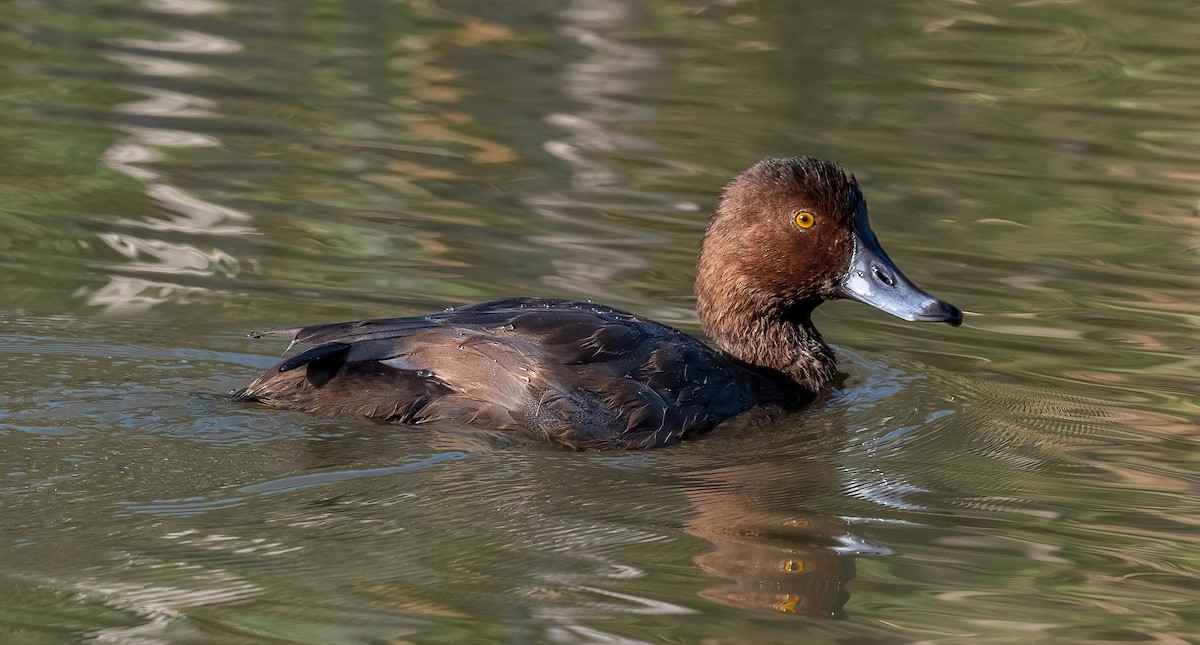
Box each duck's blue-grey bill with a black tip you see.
[838,207,962,327]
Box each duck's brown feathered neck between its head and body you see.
[696,291,838,393]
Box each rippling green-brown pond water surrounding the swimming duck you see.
[0,0,1200,644]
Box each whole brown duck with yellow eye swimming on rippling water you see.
[230,157,962,450]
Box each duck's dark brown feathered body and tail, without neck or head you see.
[233,299,762,447]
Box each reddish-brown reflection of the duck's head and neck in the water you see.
[670,424,894,617]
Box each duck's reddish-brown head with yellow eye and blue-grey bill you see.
[696,157,962,381]
